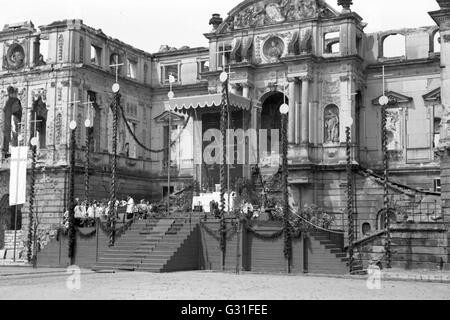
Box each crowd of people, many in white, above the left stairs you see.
[63,196,156,228]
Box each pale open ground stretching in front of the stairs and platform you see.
[0,272,450,300]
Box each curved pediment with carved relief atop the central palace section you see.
[217,0,338,33]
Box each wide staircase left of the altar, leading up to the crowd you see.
[92,218,198,272]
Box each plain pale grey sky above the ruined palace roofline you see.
[0,0,439,53]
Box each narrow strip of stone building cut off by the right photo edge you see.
[429,0,450,224]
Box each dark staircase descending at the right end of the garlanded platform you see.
[310,230,365,274]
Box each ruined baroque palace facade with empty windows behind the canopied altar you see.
[0,0,445,255]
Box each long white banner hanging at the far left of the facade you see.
[9,147,28,206]
